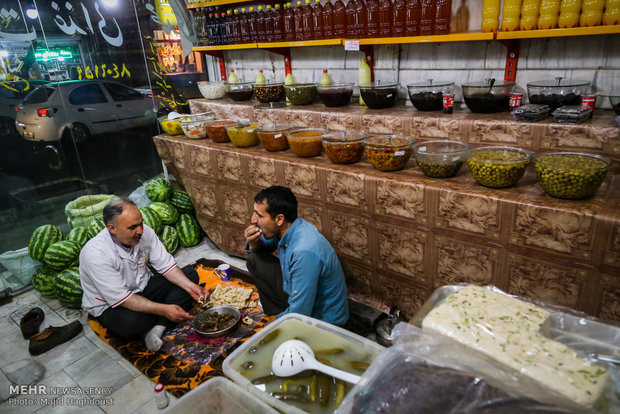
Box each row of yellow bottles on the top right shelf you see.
[482,0,620,32]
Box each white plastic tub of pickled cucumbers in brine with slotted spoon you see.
[224,313,385,414]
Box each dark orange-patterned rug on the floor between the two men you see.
[88,261,274,397]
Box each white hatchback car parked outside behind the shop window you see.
[15,79,165,143]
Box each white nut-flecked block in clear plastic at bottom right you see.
[422,286,610,406]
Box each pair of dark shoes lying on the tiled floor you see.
[19,308,82,355]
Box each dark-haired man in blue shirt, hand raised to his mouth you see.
[244,186,349,325]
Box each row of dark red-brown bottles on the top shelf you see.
[194,0,452,45]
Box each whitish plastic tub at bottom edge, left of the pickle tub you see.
[164,377,277,414]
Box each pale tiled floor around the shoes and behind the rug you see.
[0,238,246,414]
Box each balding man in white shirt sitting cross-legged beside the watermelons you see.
[80,199,208,351]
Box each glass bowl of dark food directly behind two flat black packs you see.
[527,77,591,109]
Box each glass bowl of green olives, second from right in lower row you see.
[467,146,532,188]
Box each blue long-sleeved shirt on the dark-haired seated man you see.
[252,218,349,325]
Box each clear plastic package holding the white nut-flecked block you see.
[410,285,620,413]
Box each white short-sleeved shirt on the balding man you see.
[80,225,177,316]
